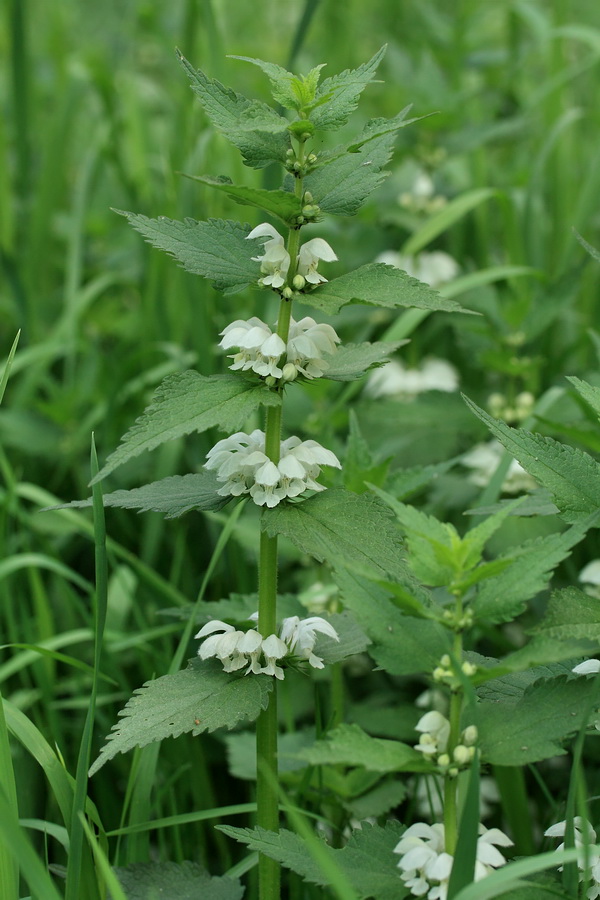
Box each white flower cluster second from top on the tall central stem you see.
[219,316,340,381]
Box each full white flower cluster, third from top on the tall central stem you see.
[204,429,341,507]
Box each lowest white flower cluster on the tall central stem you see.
[196,616,339,679]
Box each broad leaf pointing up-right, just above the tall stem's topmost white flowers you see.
[304,132,396,216]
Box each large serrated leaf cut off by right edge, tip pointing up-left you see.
[464,397,600,522]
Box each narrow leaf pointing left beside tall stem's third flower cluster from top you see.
[57,469,231,519]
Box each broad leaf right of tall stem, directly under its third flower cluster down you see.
[262,488,404,577]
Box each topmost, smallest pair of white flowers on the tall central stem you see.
[247,222,337,290]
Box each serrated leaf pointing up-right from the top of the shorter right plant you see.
[471,515,595,622]
